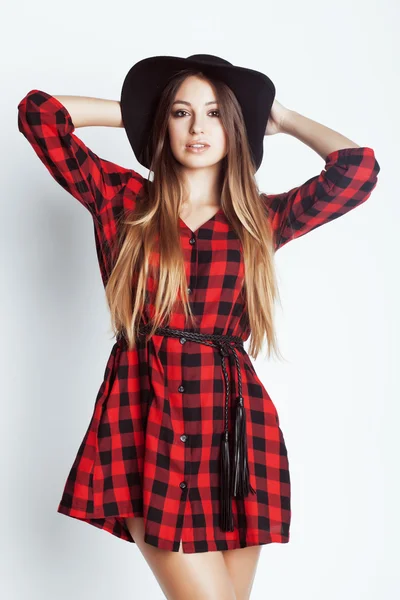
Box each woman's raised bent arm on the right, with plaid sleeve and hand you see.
[261,99,380,249]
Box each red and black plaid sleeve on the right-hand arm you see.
[261,146,380,250]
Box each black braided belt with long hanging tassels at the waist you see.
[139,324,256,531]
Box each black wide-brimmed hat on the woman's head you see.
[120,54,275,170]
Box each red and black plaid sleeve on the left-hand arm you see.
[18,89,141,217]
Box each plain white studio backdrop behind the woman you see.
[0,0,400,600]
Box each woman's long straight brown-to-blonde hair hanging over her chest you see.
[105,70,280,358]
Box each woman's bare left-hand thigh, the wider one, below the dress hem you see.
[125,517,236,600]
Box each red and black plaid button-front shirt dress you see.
[18,90,380,552]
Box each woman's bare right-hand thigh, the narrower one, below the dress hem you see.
[222,546,261,600]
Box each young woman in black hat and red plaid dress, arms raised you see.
[18,55,380,600]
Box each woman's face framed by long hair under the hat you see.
[168,76,227,169]
